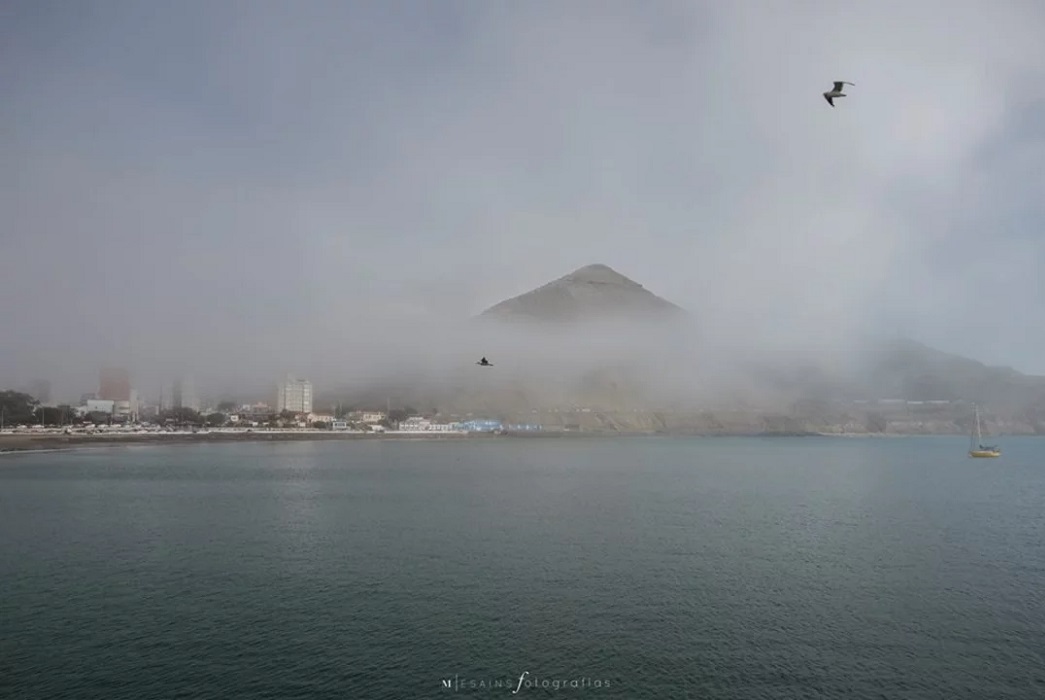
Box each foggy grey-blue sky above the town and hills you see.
[0,0,1045,403]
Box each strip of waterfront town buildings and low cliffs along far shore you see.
[0,361,1039,450]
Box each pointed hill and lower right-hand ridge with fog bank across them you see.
[332,264,1045,431]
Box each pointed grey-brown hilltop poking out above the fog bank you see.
[480,264,686,322]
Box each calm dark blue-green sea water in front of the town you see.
[0,438,1045,700]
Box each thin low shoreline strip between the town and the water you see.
[0,431,978,457]
